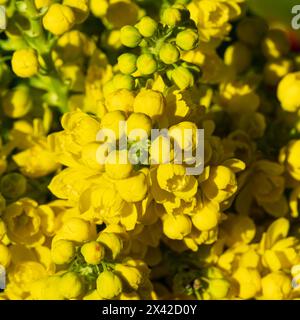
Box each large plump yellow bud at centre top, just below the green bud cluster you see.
[133,89,165,121]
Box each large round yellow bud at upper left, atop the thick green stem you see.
[43,3,76,36]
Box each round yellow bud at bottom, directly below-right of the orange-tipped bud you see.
[97,271,122,299]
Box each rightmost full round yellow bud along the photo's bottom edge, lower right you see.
[261,271,292,300]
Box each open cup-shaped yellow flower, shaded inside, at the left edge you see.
[3,199,45,246]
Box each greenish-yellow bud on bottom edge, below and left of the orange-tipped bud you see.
[59,272,84,299]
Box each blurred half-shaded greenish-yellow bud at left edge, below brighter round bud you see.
[2,85,32,119]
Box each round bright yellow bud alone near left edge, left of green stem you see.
[11,49,39,78]
